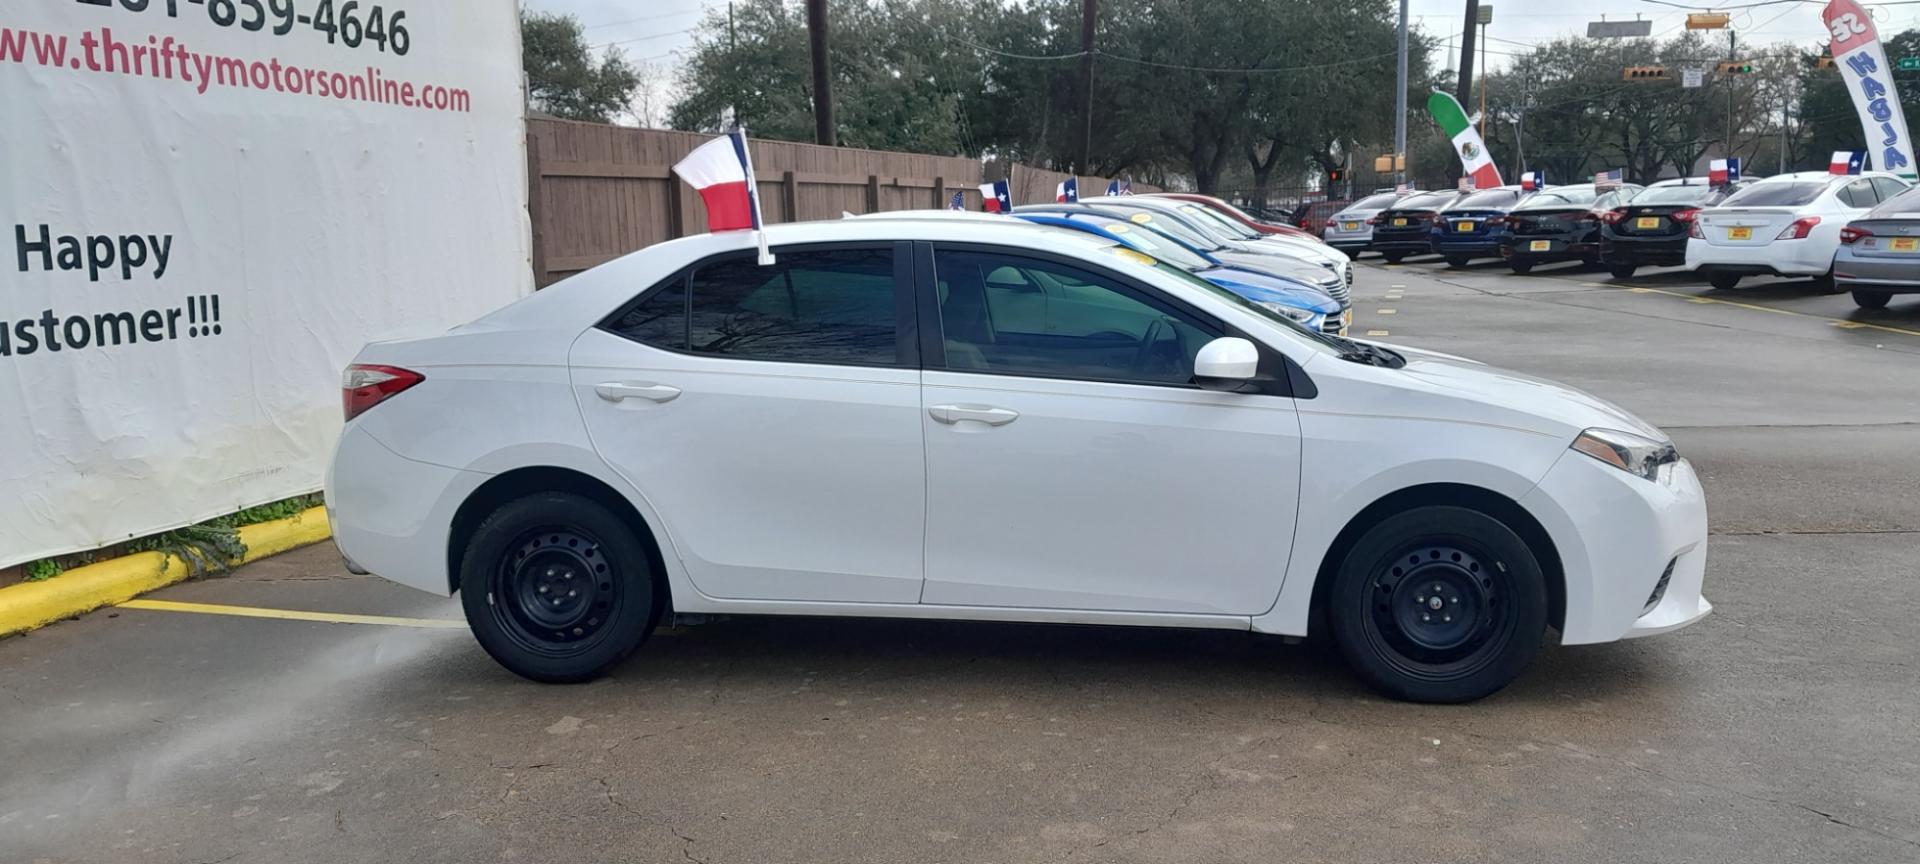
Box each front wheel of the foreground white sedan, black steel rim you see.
[1327,507,1548,703]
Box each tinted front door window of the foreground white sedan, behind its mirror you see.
[935,252,1215,386]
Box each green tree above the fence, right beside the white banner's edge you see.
[520,10,639,123]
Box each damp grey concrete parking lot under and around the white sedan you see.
[0,259,1920,864]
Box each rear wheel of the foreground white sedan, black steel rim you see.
[461,492,662,684]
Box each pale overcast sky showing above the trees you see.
[524,0,1920,121]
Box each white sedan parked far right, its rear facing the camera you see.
[1686,171,1907,292]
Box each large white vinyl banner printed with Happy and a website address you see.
[0,0,532,566]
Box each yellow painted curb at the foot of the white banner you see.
[0,507,332,636]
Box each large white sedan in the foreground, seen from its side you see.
[326,219,1713,701]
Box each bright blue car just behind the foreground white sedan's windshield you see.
[1014,209,1346,336]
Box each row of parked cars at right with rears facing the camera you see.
[1323,171,1920,309]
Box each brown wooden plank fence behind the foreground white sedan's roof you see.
[526,119,1156,288]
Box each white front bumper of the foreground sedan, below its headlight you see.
[1521,449,1713,645]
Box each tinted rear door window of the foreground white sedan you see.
[607,250,899,365]
